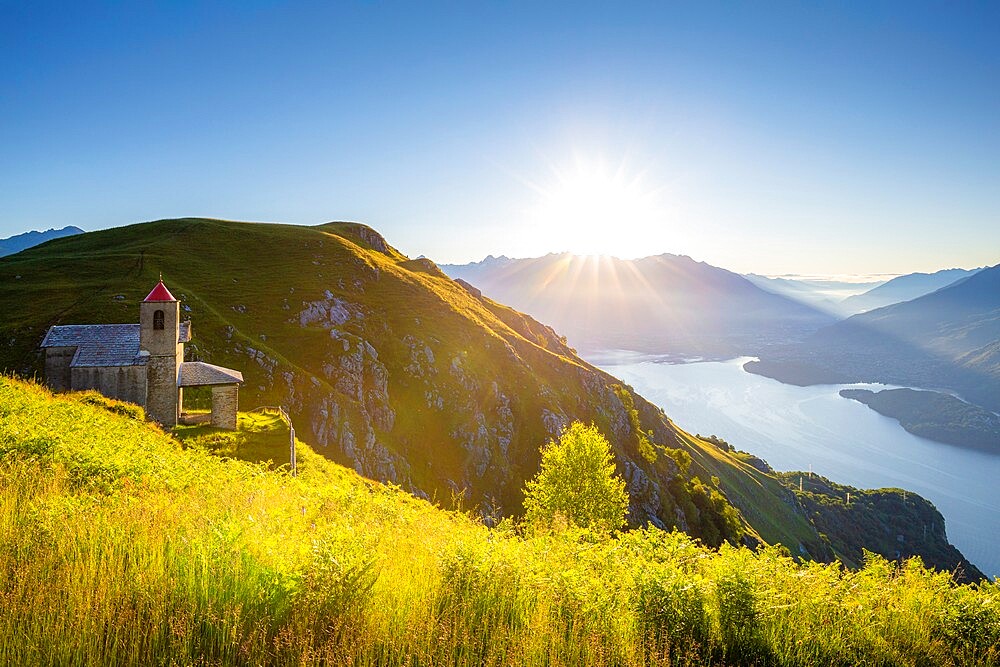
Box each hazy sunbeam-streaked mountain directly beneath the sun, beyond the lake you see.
[442,253,834,356]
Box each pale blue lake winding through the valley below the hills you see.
[587,351,1000,577]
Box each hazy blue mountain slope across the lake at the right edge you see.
[747,265,1000,412]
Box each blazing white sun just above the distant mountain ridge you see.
[529,156,666,257]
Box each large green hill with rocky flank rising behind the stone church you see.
[0,219,823,556]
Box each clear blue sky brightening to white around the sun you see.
[0,0,1000,274]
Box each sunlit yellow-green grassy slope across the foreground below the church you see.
[0,379,1000,665]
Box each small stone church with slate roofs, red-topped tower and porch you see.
[41,278,243,429]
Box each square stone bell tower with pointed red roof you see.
[139,276,184,427]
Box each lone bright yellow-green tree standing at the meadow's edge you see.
[524,422,628,530]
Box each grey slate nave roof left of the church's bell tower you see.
[41,324,146,366]
